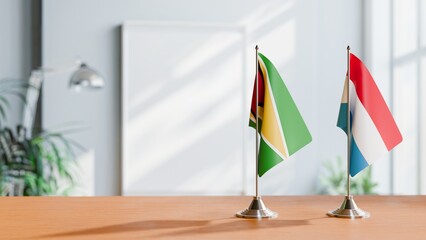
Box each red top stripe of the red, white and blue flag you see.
[350,53,402,151]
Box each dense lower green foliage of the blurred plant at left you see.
[0,122,78,195]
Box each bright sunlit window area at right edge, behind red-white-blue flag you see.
[365,0,426,195]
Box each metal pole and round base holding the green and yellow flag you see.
[235,45,278,219]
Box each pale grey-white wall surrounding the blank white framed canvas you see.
[43,0,363,195]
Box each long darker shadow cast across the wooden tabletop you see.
[39,218,316,238]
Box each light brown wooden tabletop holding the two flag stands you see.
[0,196,426,240]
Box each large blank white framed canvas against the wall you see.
[122,22,246,195]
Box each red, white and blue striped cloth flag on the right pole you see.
[337,53,402,177]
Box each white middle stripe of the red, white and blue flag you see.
[350,81,388,164]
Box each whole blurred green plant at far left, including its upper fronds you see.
[0,80,81,196]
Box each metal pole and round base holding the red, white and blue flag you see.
[327,46,370,219]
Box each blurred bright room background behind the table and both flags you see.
[0,0,426,196]
